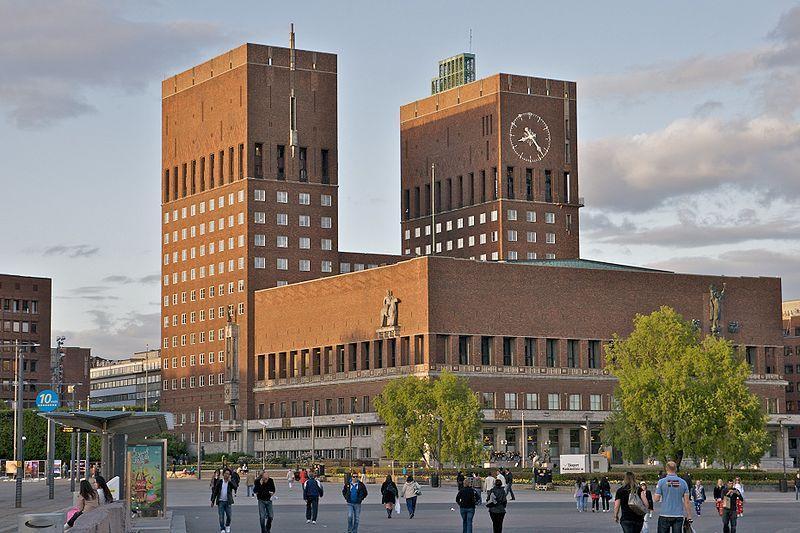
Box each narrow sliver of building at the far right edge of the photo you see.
[783,300,800,466]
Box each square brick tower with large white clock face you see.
[400,70,583,261]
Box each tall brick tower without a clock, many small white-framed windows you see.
[161,34,397,451]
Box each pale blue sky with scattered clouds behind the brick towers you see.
[0,0,800,357]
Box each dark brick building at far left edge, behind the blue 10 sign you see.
[0,274,52,407]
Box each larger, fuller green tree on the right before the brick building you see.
[604,307,769,466]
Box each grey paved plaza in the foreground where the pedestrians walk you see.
[169,480,800,533]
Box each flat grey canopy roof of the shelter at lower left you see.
[39,411,175,438]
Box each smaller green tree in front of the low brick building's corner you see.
[375,372,483,465]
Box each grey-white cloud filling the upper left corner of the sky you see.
[0,0,228,128]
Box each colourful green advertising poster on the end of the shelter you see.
[125,440,166,516]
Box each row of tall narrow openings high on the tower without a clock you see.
[163,143,330,202]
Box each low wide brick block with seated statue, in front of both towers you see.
[247,257,786,465]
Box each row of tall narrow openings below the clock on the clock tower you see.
[402,165,574,220]
